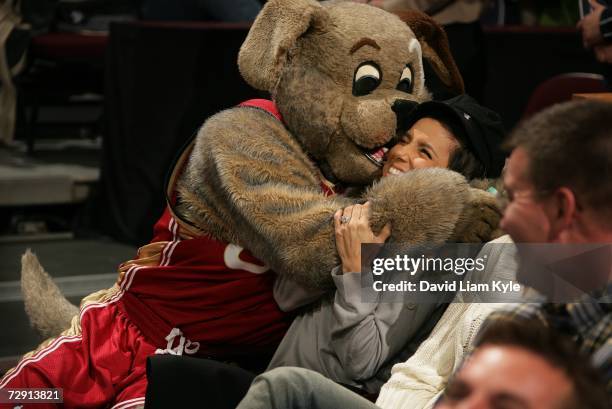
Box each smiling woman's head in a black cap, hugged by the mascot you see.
[383,95,505,179]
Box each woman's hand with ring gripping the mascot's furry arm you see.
[334,202,391,273]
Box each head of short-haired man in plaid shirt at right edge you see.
[501,101,612,243]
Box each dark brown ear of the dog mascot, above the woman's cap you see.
[393,10,465,94]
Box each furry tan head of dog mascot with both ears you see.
[238,0,463,184]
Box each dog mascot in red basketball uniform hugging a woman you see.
[0,0,499,409]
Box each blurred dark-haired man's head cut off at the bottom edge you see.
[436,320,608,409]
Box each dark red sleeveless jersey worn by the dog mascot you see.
[119,100,290,359]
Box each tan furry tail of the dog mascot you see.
[21,249,79,337]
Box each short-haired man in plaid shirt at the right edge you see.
[478,101,612,396]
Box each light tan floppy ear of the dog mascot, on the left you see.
[238,0,328,91]
